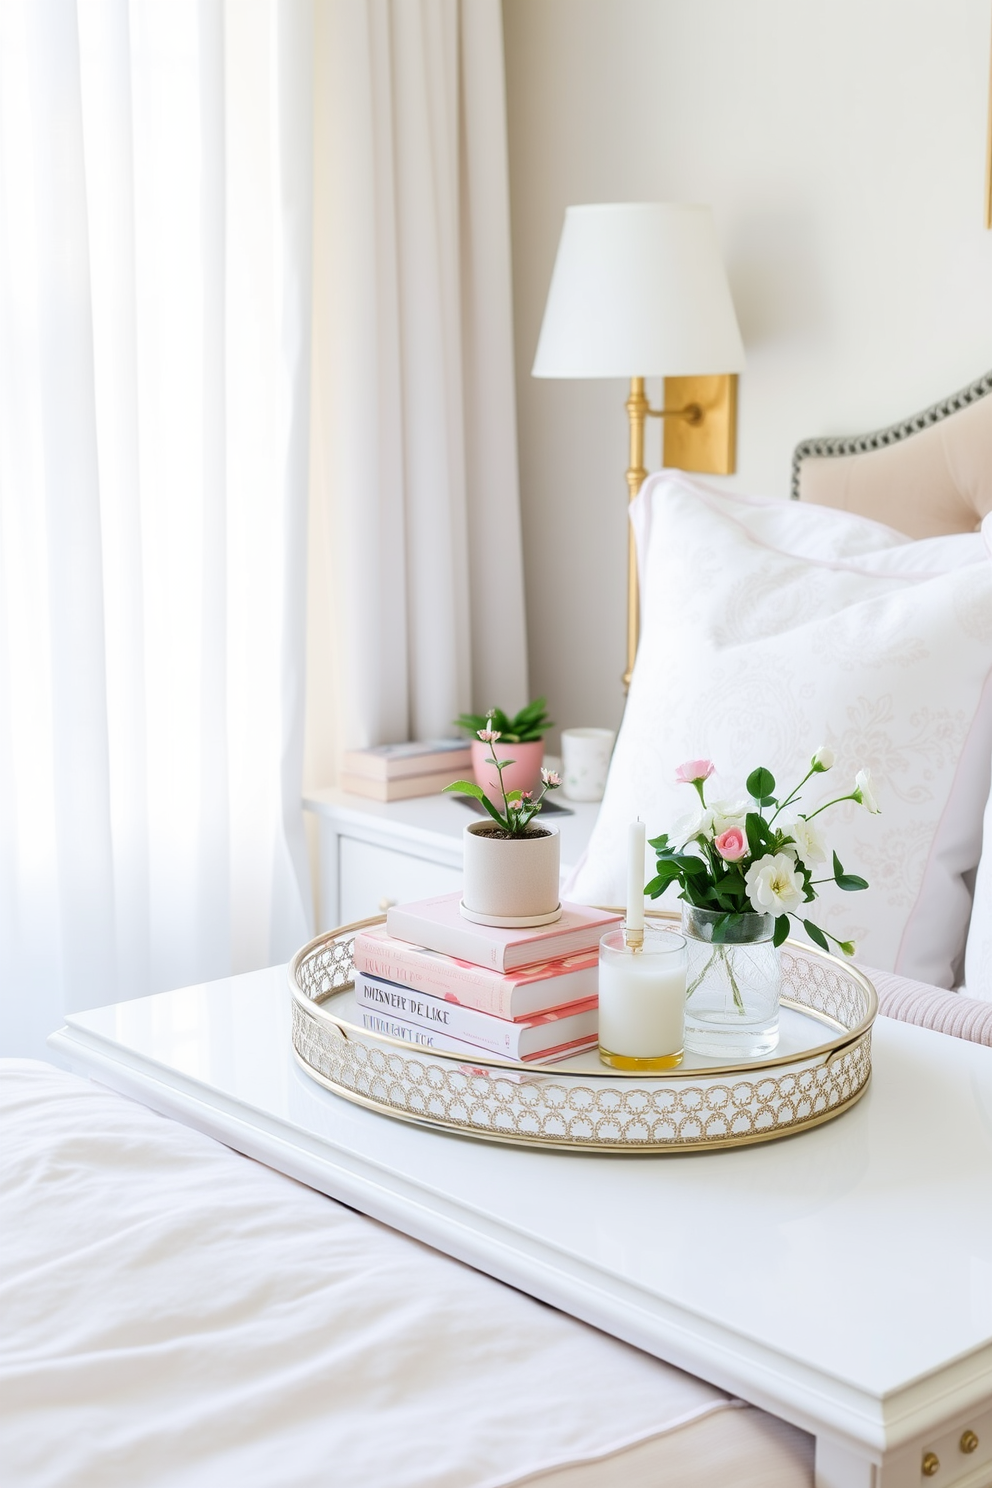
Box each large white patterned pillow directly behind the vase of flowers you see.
[565,472,992,987]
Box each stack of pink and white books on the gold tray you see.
[354,893,620,1064]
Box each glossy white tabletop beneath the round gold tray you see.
[55,969,992,1448]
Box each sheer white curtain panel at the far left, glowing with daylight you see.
[0,0,312,1055]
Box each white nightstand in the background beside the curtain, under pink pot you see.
[303,789,599,933]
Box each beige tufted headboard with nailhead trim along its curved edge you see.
[793,372,992,537]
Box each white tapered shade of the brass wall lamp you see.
[534,202,744,378]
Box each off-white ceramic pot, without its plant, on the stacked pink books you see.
[461,817,562,927]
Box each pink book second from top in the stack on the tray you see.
[352,926,599,1021]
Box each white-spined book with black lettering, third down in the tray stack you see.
[355,972,599,1059]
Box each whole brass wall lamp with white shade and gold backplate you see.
[532,202,744,690]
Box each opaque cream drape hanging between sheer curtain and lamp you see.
[308,0,526,784]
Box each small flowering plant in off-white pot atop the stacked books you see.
[445,714,562,926]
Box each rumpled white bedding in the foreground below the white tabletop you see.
[0,1061,812,1488]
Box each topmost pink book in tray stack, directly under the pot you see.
[385,890,622,972]
